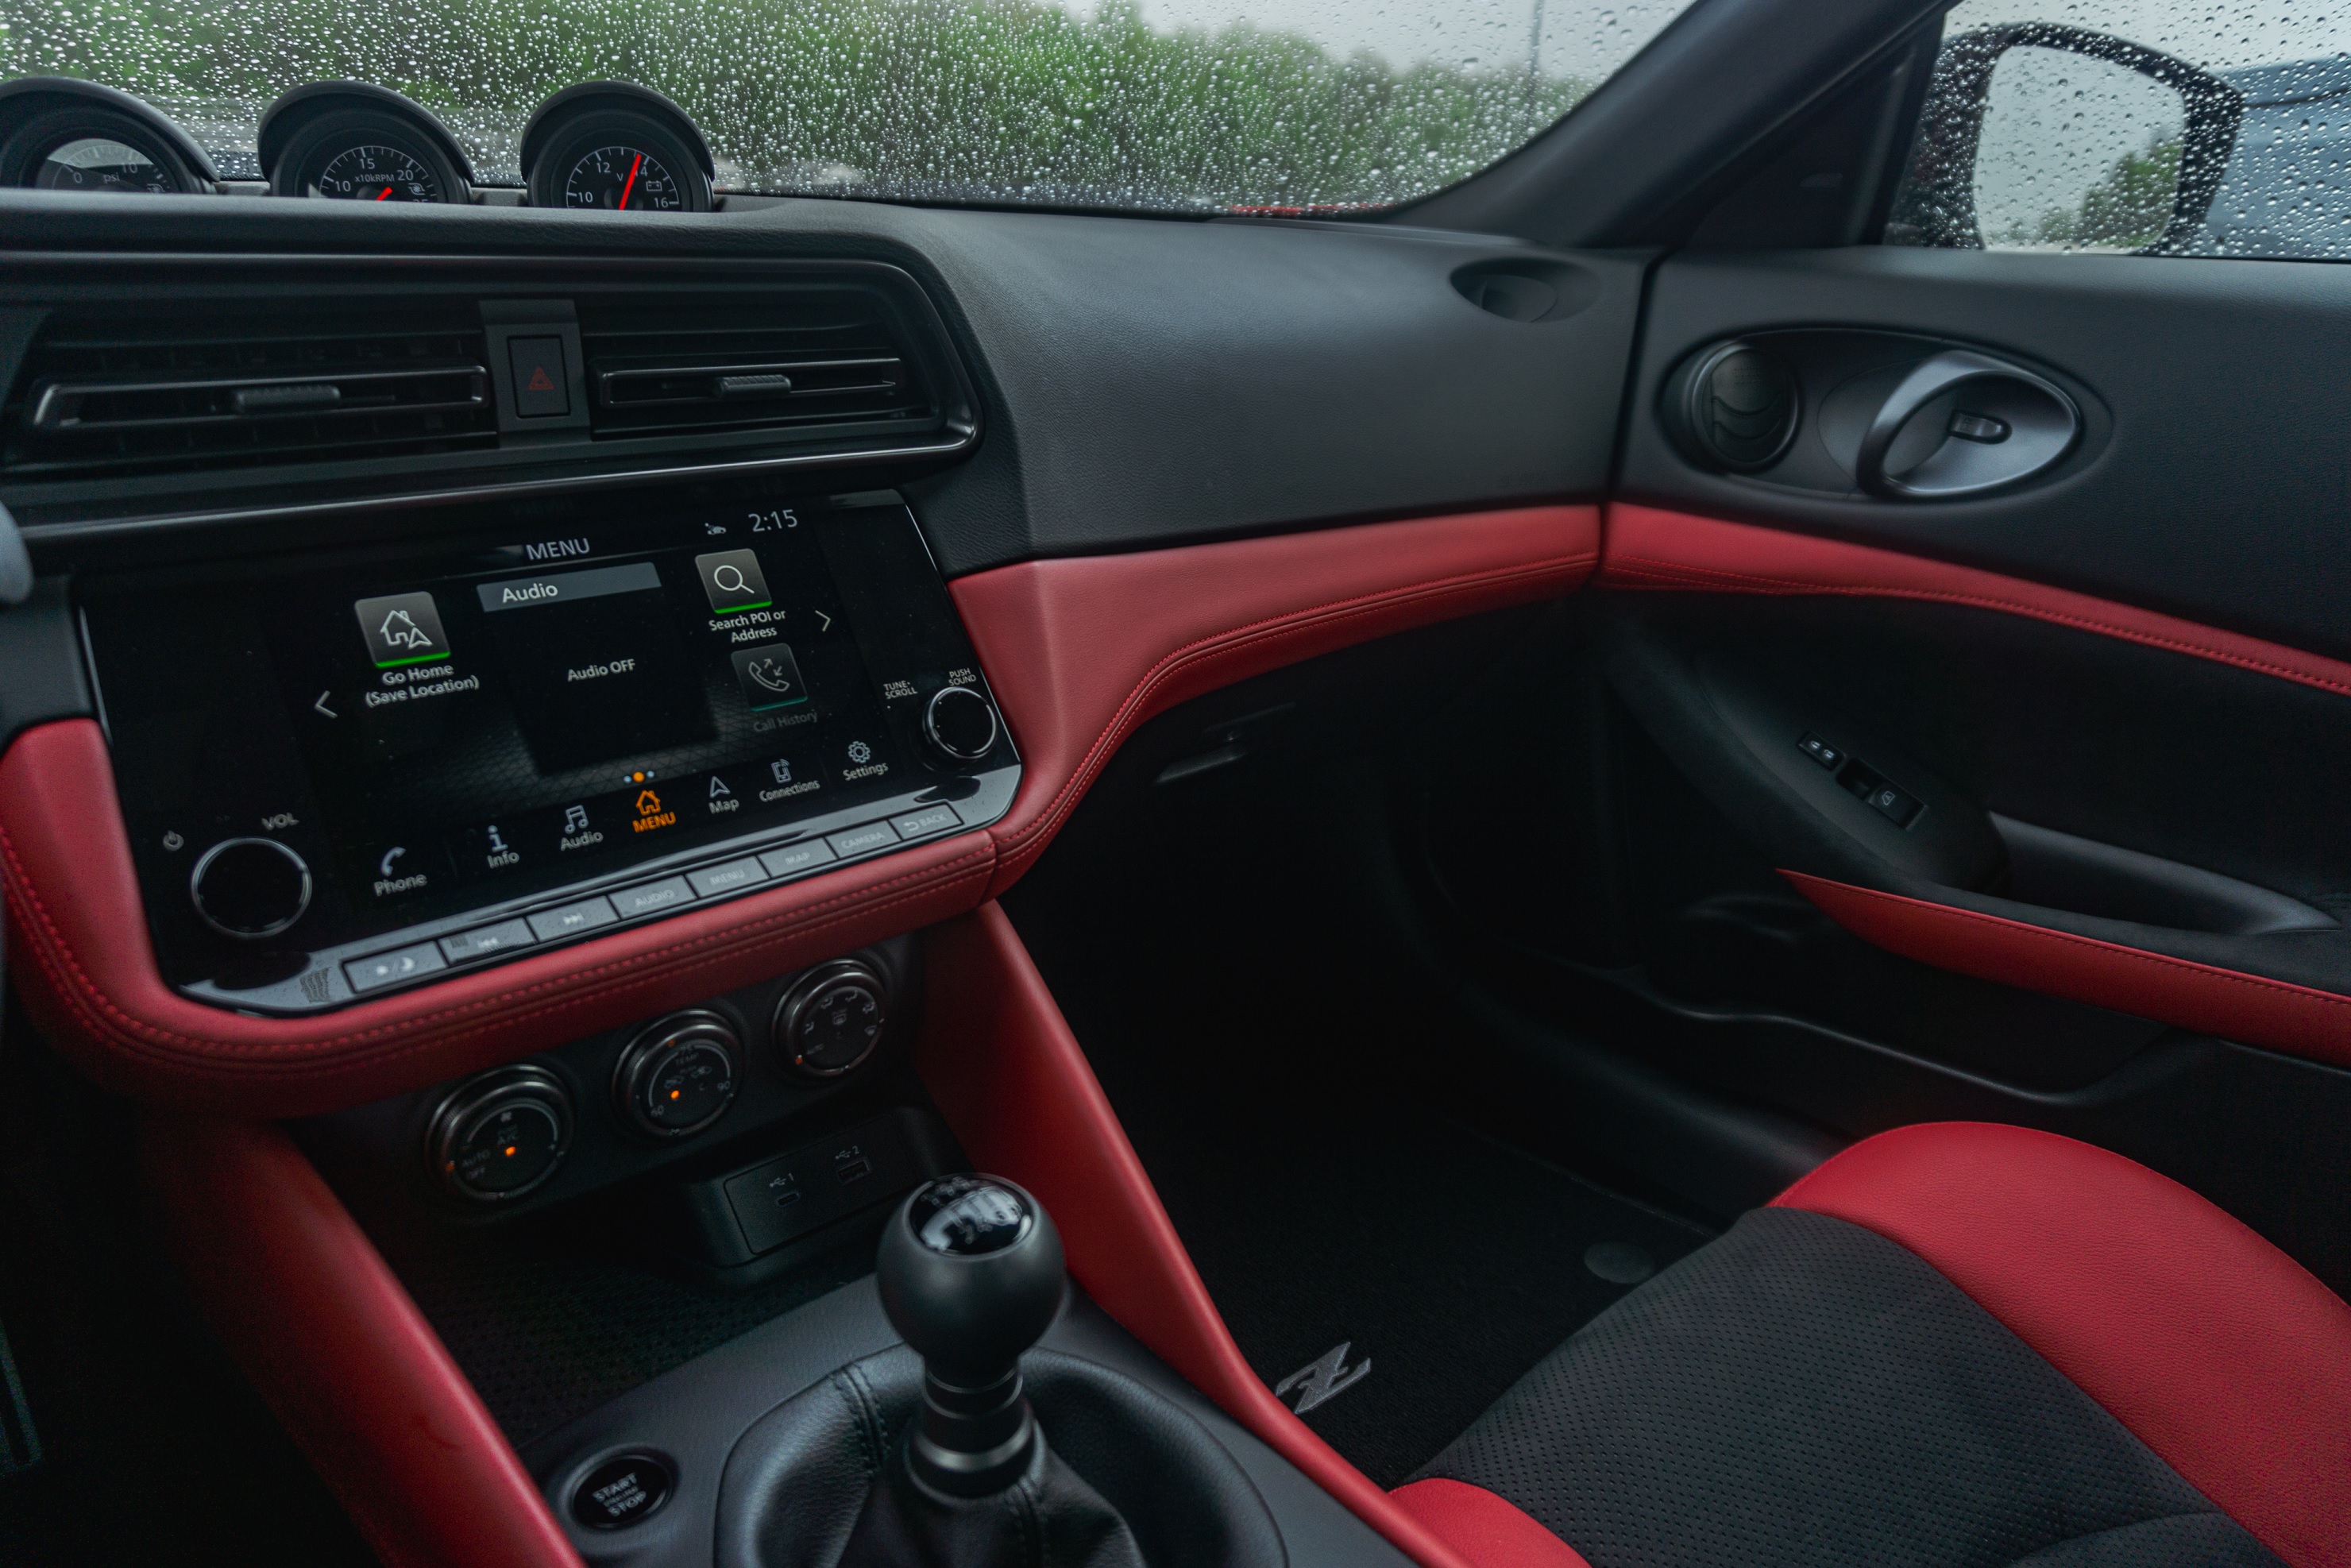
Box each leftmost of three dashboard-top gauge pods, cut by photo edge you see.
[0,75,221,195]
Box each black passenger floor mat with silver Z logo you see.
[1112,1067,1707,1485]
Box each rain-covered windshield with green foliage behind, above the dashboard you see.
[0,0,1688,211]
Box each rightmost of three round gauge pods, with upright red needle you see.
[522,83,717,211]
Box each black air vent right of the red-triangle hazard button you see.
[581,294,936,437]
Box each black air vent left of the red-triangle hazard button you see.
[5,306,496,480]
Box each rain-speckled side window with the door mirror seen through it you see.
[1886,0,2351,259]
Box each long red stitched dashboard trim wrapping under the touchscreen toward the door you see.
[0,505,1599,1117]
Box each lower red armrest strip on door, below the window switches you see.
[1780,870,2351,1068]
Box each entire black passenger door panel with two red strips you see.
[1392,236,2351,1284]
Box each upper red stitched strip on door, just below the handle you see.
[1599,503,2351,696]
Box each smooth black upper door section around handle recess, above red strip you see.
[1617,247,2351,658]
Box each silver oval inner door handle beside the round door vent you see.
[1855,348,2081,500]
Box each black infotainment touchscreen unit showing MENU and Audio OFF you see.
[85,486,1016,1006]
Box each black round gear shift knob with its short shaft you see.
[874,1176,1063,1497]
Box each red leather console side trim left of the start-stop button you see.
[141,1117,581,1568]
